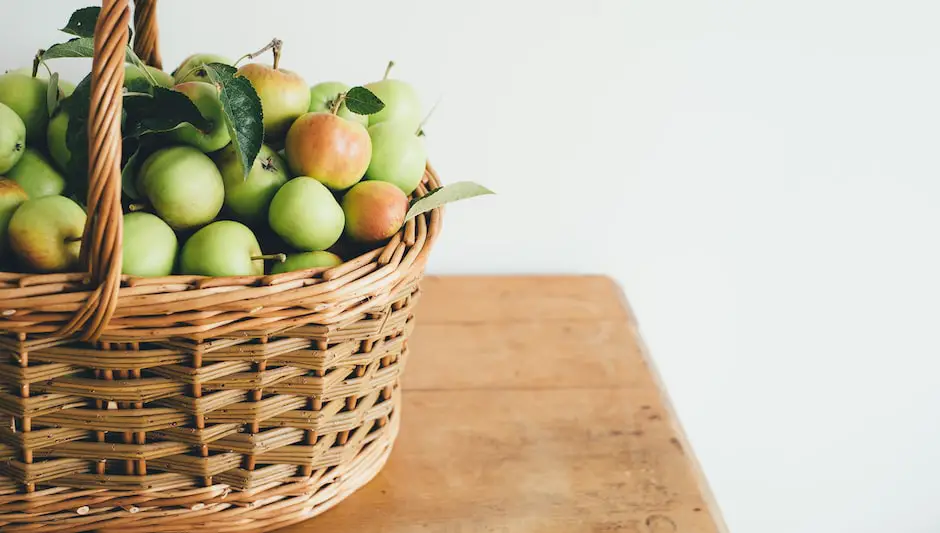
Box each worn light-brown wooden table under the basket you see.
[283,276,726,533]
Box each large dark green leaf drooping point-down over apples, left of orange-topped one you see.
[204,63,264,179]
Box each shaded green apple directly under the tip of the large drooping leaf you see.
[214,145,290,223]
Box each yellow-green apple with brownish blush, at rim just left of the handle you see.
[7,196,85,272]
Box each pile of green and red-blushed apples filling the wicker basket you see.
[0,46,427,277]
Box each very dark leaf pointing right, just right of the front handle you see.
[124,87,211,137]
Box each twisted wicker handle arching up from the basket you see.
[59,0,160,341]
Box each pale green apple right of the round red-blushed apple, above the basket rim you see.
[366,122,428,194]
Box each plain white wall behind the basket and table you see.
[0,0,940,533]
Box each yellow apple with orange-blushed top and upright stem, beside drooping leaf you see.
[236,63,310,143]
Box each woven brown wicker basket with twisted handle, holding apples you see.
[0,0,441,533]
